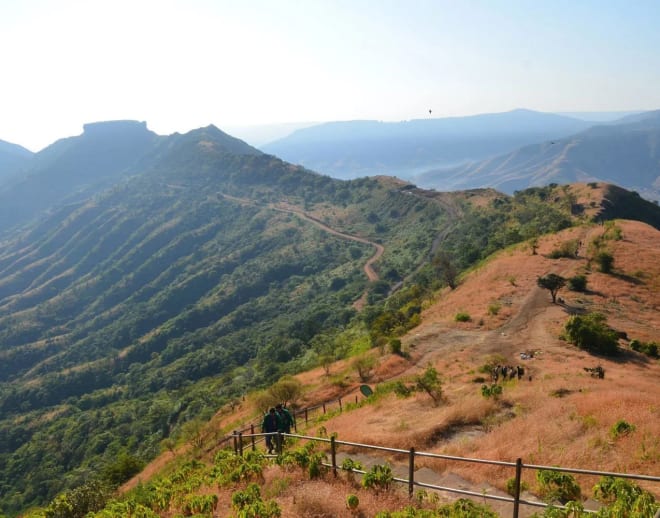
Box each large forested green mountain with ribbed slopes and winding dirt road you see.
[0,123,660,515]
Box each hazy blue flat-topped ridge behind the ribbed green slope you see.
[0,120,261,233]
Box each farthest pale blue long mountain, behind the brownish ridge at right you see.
[262,110,592,178]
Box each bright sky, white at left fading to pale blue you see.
[0,0,660,151]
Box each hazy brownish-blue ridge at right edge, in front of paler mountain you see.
[415,110,660,200]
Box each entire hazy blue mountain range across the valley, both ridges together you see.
[263,110,660,200]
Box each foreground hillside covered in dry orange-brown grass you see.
[24,217,660,517]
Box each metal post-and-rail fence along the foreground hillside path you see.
[217,396,660,518]
